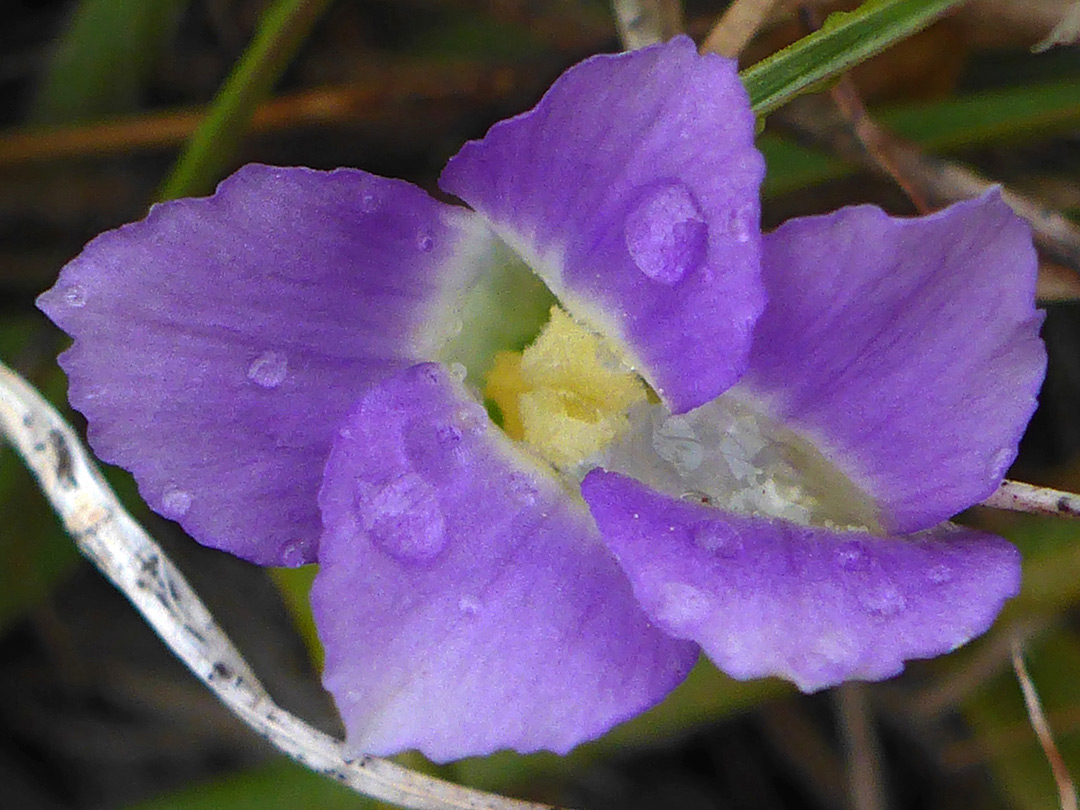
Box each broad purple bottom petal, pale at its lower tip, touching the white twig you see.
[312,365,697,760]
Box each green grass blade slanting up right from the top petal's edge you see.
[741,0,963,116]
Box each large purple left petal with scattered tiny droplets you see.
[38,165,494,565]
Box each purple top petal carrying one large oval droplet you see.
[440,37,765,411]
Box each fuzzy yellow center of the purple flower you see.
[484,307,648,472]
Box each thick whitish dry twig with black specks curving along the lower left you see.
[0,363,548,810]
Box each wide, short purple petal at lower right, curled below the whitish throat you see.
[582,470,1020,691]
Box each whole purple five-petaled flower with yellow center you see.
[40,38,1044,760]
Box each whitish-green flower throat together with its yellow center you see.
[438,244,881,531]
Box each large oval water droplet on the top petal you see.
[623,181,708,284]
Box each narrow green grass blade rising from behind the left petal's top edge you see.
[158,0,330,200]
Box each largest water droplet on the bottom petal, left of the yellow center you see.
[357,473,447,563]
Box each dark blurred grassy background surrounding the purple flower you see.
[0,0,1080,810]
